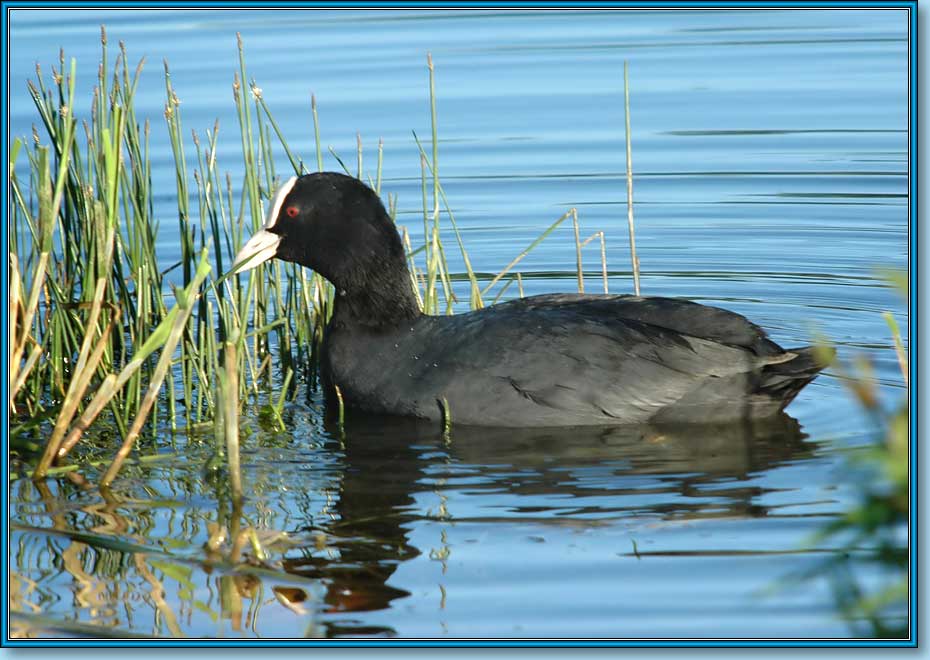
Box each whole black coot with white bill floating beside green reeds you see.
[234,173,825,427]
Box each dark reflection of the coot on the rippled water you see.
[285,414,815,636]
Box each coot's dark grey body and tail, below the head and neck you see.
[324,295,819,427]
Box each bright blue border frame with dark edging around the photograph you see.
[0,0,919,648]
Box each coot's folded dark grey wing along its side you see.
[411,297,777,426]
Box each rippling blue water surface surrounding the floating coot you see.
[10,10,908,638]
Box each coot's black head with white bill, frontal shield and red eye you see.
[233,172,418,322]
